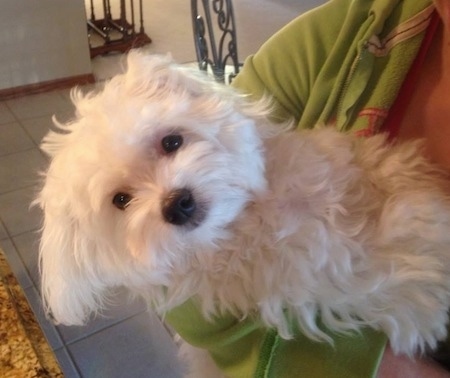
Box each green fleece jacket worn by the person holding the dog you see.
[165,0,434,378]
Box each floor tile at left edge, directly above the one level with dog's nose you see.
[0,148,48,193]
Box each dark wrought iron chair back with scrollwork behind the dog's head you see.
[191,0,241,83]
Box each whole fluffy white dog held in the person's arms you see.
[37,52,450,374]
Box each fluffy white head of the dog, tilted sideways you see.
[37,52,265,324]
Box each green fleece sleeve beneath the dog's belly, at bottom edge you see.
[164,298,386,378]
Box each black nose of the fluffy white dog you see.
[162,189,196,226]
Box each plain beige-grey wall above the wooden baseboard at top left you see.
[0,0,92,90]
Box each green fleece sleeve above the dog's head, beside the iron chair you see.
[233,0,353,125]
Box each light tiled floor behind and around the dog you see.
[0,0,323,378]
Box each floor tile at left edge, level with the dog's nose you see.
[0,187,42,236]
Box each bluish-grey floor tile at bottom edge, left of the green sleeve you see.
[68,312,182,378]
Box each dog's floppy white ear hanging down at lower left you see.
[39,204,103,325]
